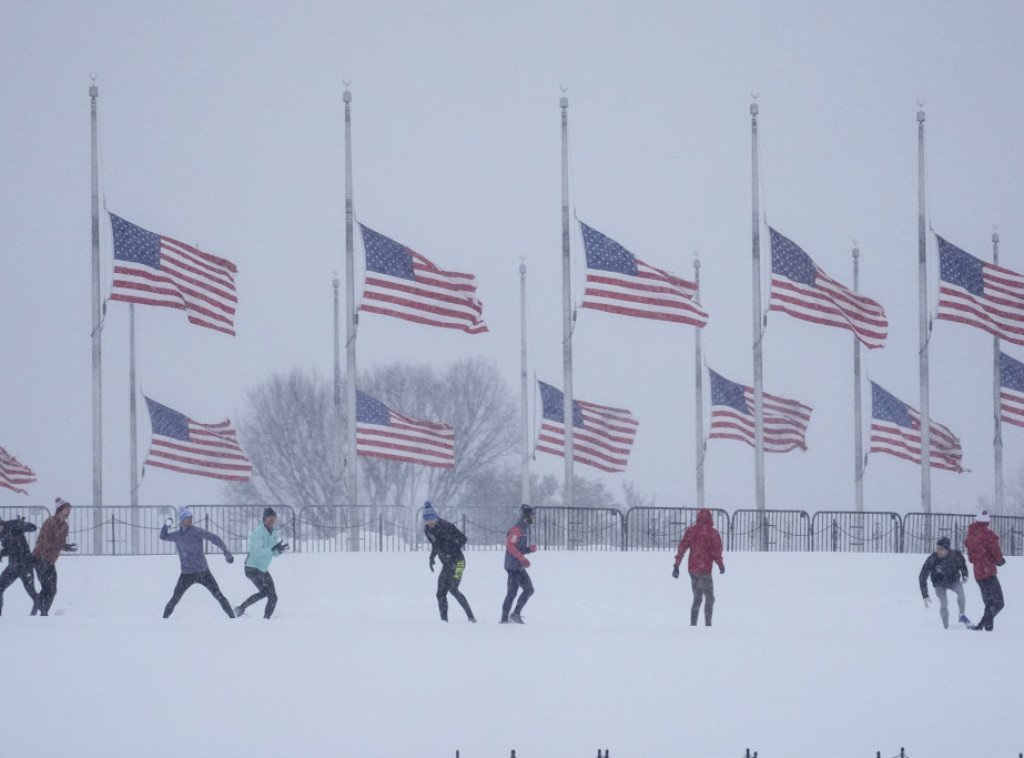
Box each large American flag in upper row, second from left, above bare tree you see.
[359,223,487,334]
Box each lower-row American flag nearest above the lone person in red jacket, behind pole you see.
[708,369,811,453]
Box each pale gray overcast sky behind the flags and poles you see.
[0,0,1024,512]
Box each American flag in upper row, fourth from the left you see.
[768,227,889,347]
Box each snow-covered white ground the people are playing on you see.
[0,552,1024,758]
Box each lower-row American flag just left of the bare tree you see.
[143,397,253,481]
